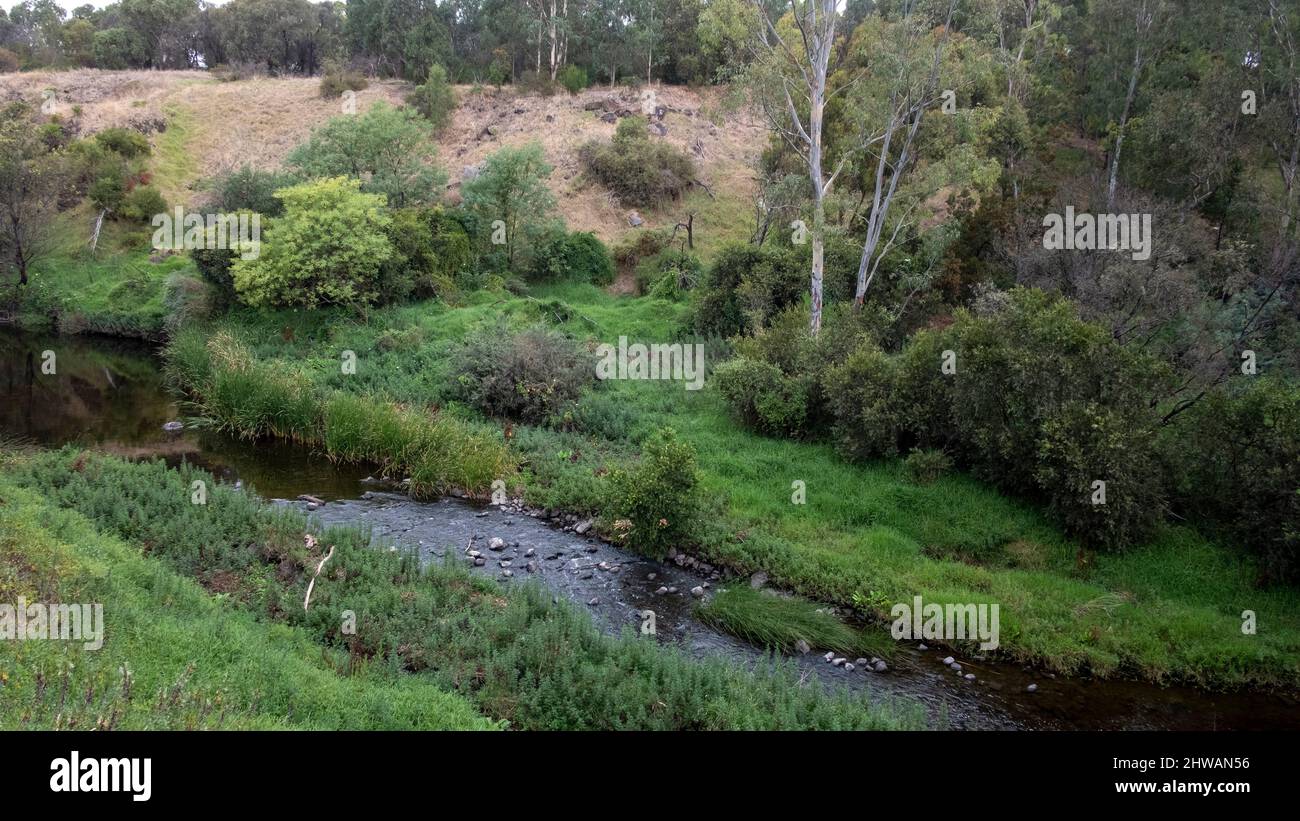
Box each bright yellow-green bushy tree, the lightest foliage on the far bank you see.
[231,177,393,308]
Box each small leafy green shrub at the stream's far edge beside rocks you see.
[605,427,699,559]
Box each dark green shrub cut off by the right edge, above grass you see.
[1161,378,1300,582]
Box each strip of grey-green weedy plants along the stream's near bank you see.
[9,449,923,729]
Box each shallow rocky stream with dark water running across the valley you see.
[0,330,1300,730]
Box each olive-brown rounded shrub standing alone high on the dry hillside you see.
[579,117,696,205]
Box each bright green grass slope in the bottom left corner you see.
[0,481,494,730]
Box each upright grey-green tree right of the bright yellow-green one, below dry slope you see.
[460,143,555,270]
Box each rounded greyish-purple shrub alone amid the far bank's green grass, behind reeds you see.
[452,327,595,423]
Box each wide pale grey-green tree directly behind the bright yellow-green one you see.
[289,101,447,208]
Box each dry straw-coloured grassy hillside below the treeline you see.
[0,69,766,256]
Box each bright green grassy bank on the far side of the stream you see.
[162,286,1300,687]
